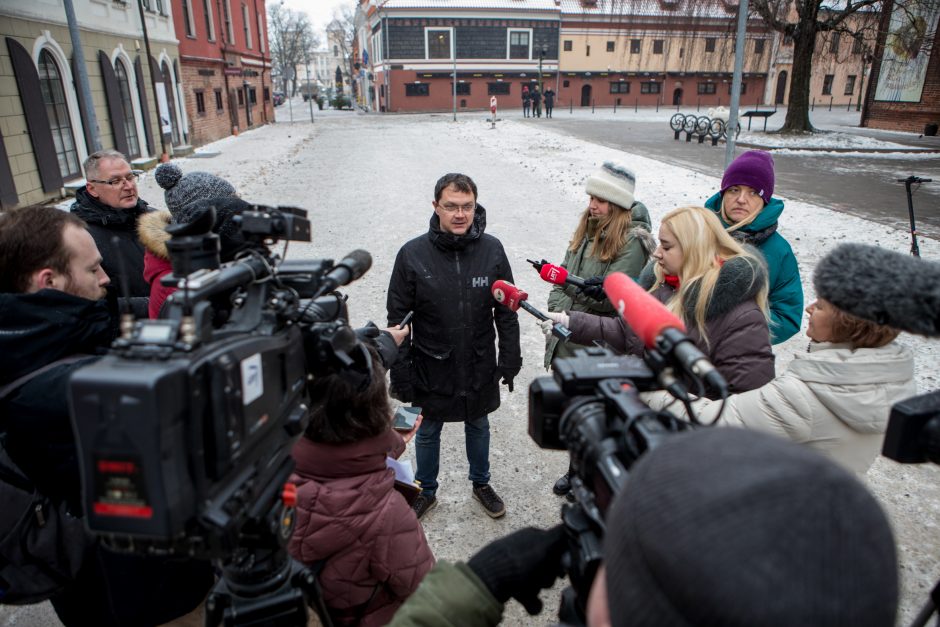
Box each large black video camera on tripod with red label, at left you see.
[70,205,371,625]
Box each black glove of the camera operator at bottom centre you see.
[467,525,567,616]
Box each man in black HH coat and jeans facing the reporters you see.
[388,174,522,518]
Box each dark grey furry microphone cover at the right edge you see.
[813,244,940,337]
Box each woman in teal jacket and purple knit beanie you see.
[705,150,803,344]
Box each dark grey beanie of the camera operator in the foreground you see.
[604,427,898,627]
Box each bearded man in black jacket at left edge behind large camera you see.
[0,207,213,626]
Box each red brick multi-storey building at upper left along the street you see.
[172,0,274,146]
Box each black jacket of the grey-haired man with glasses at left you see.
[72,188,152,297]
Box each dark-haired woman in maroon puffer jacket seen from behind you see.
[288,349,434,627]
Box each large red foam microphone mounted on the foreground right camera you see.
[604,272,728,396]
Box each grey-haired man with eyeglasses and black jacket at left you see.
[72,150,151,297]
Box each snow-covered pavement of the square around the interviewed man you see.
[9,108,940,626]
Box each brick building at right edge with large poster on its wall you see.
[861,2,940,133]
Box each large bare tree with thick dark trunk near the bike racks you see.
[750,0,884,133]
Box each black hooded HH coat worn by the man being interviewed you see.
[387,206,522,422]
